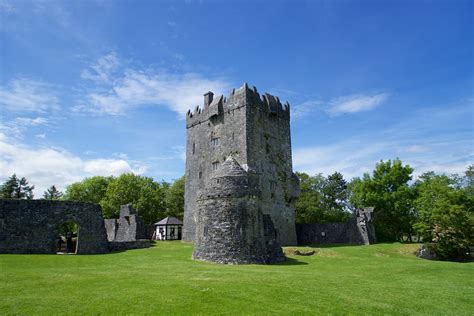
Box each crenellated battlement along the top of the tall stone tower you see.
[186,83,290,128]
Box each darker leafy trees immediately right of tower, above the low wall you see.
[295,172,350,223]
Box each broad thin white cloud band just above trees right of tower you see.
[293,102,474,179]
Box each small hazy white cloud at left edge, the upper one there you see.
[0,78,59,113]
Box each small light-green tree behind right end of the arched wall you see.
[64,176,114,204]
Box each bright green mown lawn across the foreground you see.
[0,242,474,315]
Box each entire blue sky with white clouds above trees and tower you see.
[0,0,474,197]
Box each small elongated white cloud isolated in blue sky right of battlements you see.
[329,93,389,115]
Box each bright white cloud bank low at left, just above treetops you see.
[0,133,146,198]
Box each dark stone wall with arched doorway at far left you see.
[0,200,108,254]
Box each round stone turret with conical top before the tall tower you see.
[193,157,285,264]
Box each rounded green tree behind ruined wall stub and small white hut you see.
[100,173,166,224]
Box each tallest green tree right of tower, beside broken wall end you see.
[350,159,416,241]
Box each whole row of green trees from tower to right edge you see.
[295,159,474,260]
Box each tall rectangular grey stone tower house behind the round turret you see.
[183,84,299,245]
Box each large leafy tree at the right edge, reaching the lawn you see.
[414,172,474,260]
